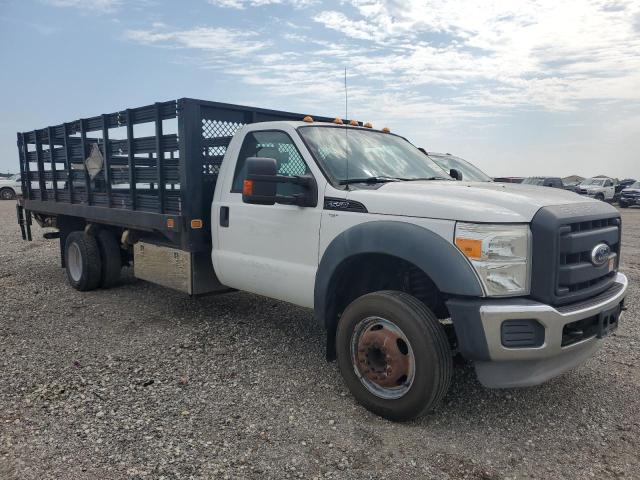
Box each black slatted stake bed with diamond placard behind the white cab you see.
[18,98,331,253]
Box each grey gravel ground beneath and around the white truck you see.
[0,202,640,480]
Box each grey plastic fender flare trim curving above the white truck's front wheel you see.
[314,221,484,329]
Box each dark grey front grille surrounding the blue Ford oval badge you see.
[531,202,621,305]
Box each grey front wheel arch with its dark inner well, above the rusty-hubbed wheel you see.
[314,221,483,358]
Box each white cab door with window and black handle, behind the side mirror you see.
[212,127,326,307]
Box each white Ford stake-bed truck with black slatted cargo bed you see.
[18,99,627,420]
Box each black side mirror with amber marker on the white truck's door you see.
[242,157,318,207]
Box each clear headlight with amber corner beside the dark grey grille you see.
[455,222,531,297]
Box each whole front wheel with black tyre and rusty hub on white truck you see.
[336,291,452,421]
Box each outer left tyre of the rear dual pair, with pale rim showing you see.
[65,231,102,292]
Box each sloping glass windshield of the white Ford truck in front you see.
[298,126,451,183]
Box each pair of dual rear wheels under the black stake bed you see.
[65,230,122,292]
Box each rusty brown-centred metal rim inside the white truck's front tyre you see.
[351,317,416,399]
